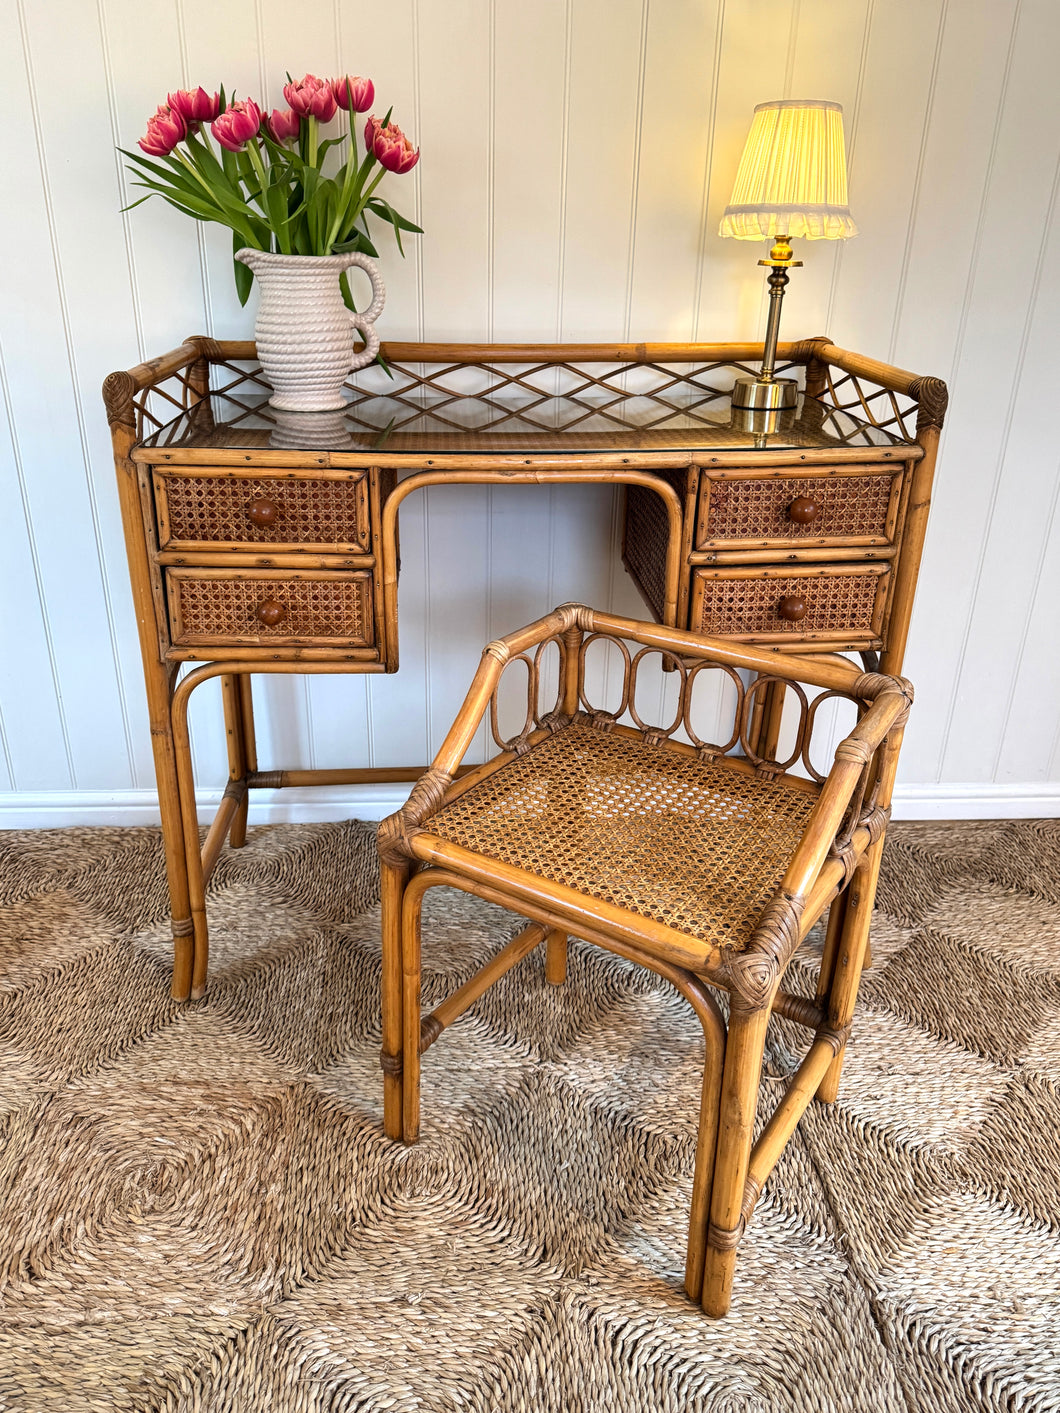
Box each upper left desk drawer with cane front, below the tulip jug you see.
[154,466,372,554]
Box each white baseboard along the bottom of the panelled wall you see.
[0,781,1060,829]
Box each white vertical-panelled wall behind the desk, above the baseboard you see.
[0,0,1060,827]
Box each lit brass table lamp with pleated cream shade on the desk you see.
[719,99,858,411]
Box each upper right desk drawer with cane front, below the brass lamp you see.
[695,465,903,550]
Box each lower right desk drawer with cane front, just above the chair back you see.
[690,564,890,646]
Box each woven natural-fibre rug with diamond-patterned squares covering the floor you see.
[0,822,1060,1413]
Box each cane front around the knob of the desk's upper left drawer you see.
[155,472,372,552]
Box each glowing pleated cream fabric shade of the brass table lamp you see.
[719,99,858,240]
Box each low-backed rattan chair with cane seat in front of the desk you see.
[379,603,912,1316]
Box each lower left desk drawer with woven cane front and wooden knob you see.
[165,569,375,647]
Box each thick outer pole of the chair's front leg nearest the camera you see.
[702,996,769,1318]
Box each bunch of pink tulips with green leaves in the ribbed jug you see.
[122,73,421,308]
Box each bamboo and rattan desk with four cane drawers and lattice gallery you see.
[103,338,946,998]
